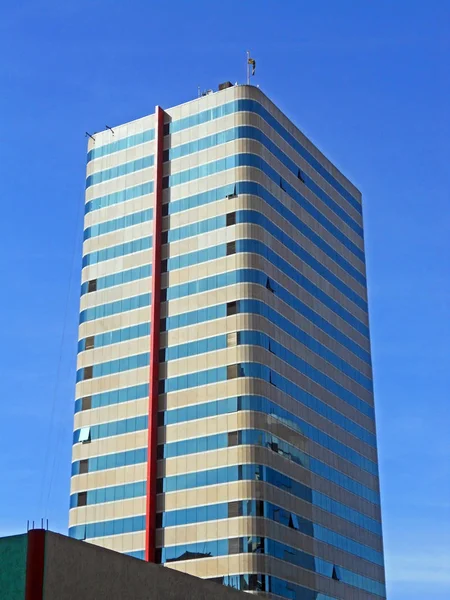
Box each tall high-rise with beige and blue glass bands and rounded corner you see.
[70,84,385,600]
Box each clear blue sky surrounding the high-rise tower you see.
[0,0,450,600]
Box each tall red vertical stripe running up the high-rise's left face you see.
[145,106,164,562]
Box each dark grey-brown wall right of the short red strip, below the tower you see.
[44,532,247,600]
